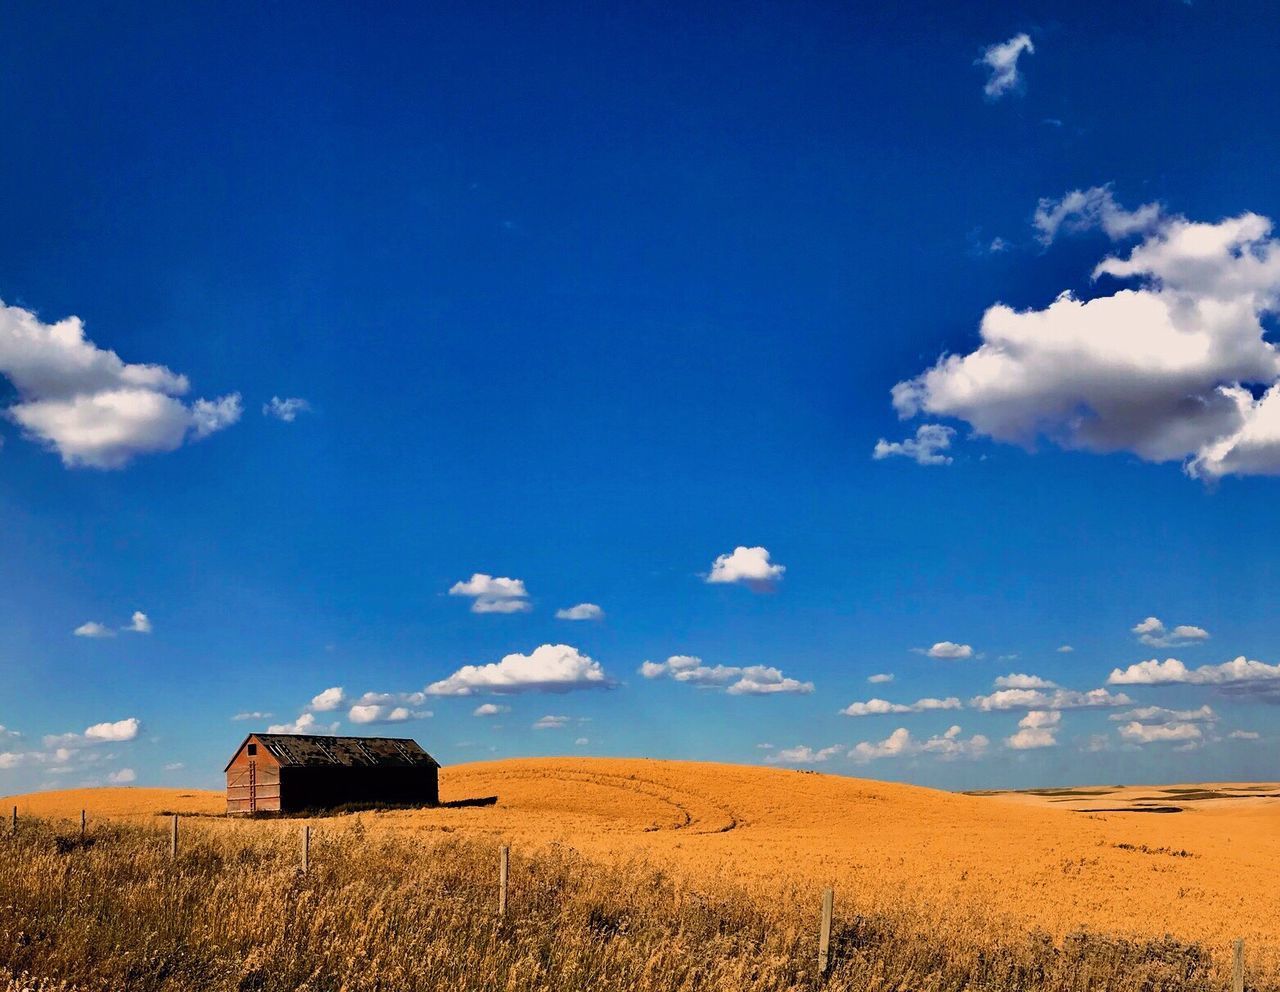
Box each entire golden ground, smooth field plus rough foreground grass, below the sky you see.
[0,759,1280,991]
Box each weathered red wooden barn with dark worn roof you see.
[225,733,440,813]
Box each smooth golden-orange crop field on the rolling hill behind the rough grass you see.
[3,758,1280,952]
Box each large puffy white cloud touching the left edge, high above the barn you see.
[0,302,239,468]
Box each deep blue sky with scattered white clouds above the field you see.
[0,0,1280,792]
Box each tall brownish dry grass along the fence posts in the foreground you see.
[0,818,1264,992]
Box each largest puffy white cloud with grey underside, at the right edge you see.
[892,199,1280,479]
